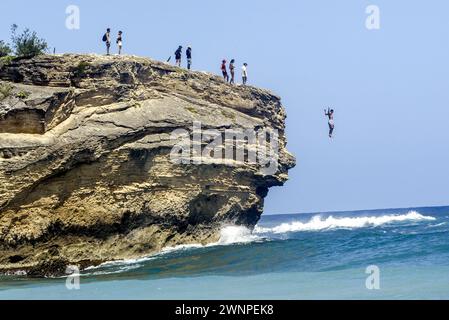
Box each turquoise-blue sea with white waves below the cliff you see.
[0,207,449,299]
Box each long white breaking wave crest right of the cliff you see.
[254,211,436,234]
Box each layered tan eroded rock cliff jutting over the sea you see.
[0,55,295,275]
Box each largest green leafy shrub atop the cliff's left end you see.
[11,24,48,57]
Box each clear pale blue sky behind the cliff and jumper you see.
[0,0,449,213]
